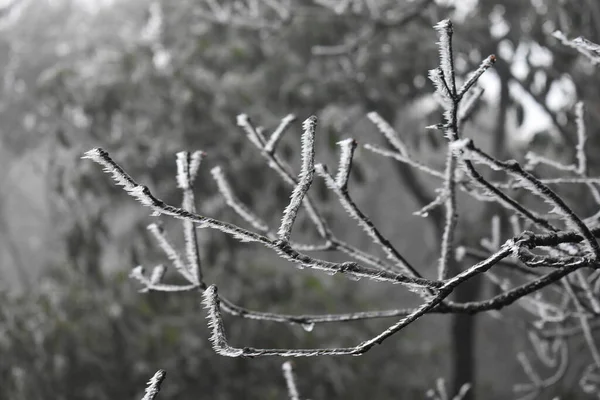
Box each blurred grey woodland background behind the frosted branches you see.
[0,0,600,400]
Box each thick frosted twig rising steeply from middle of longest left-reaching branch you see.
[277,115,317,241]
